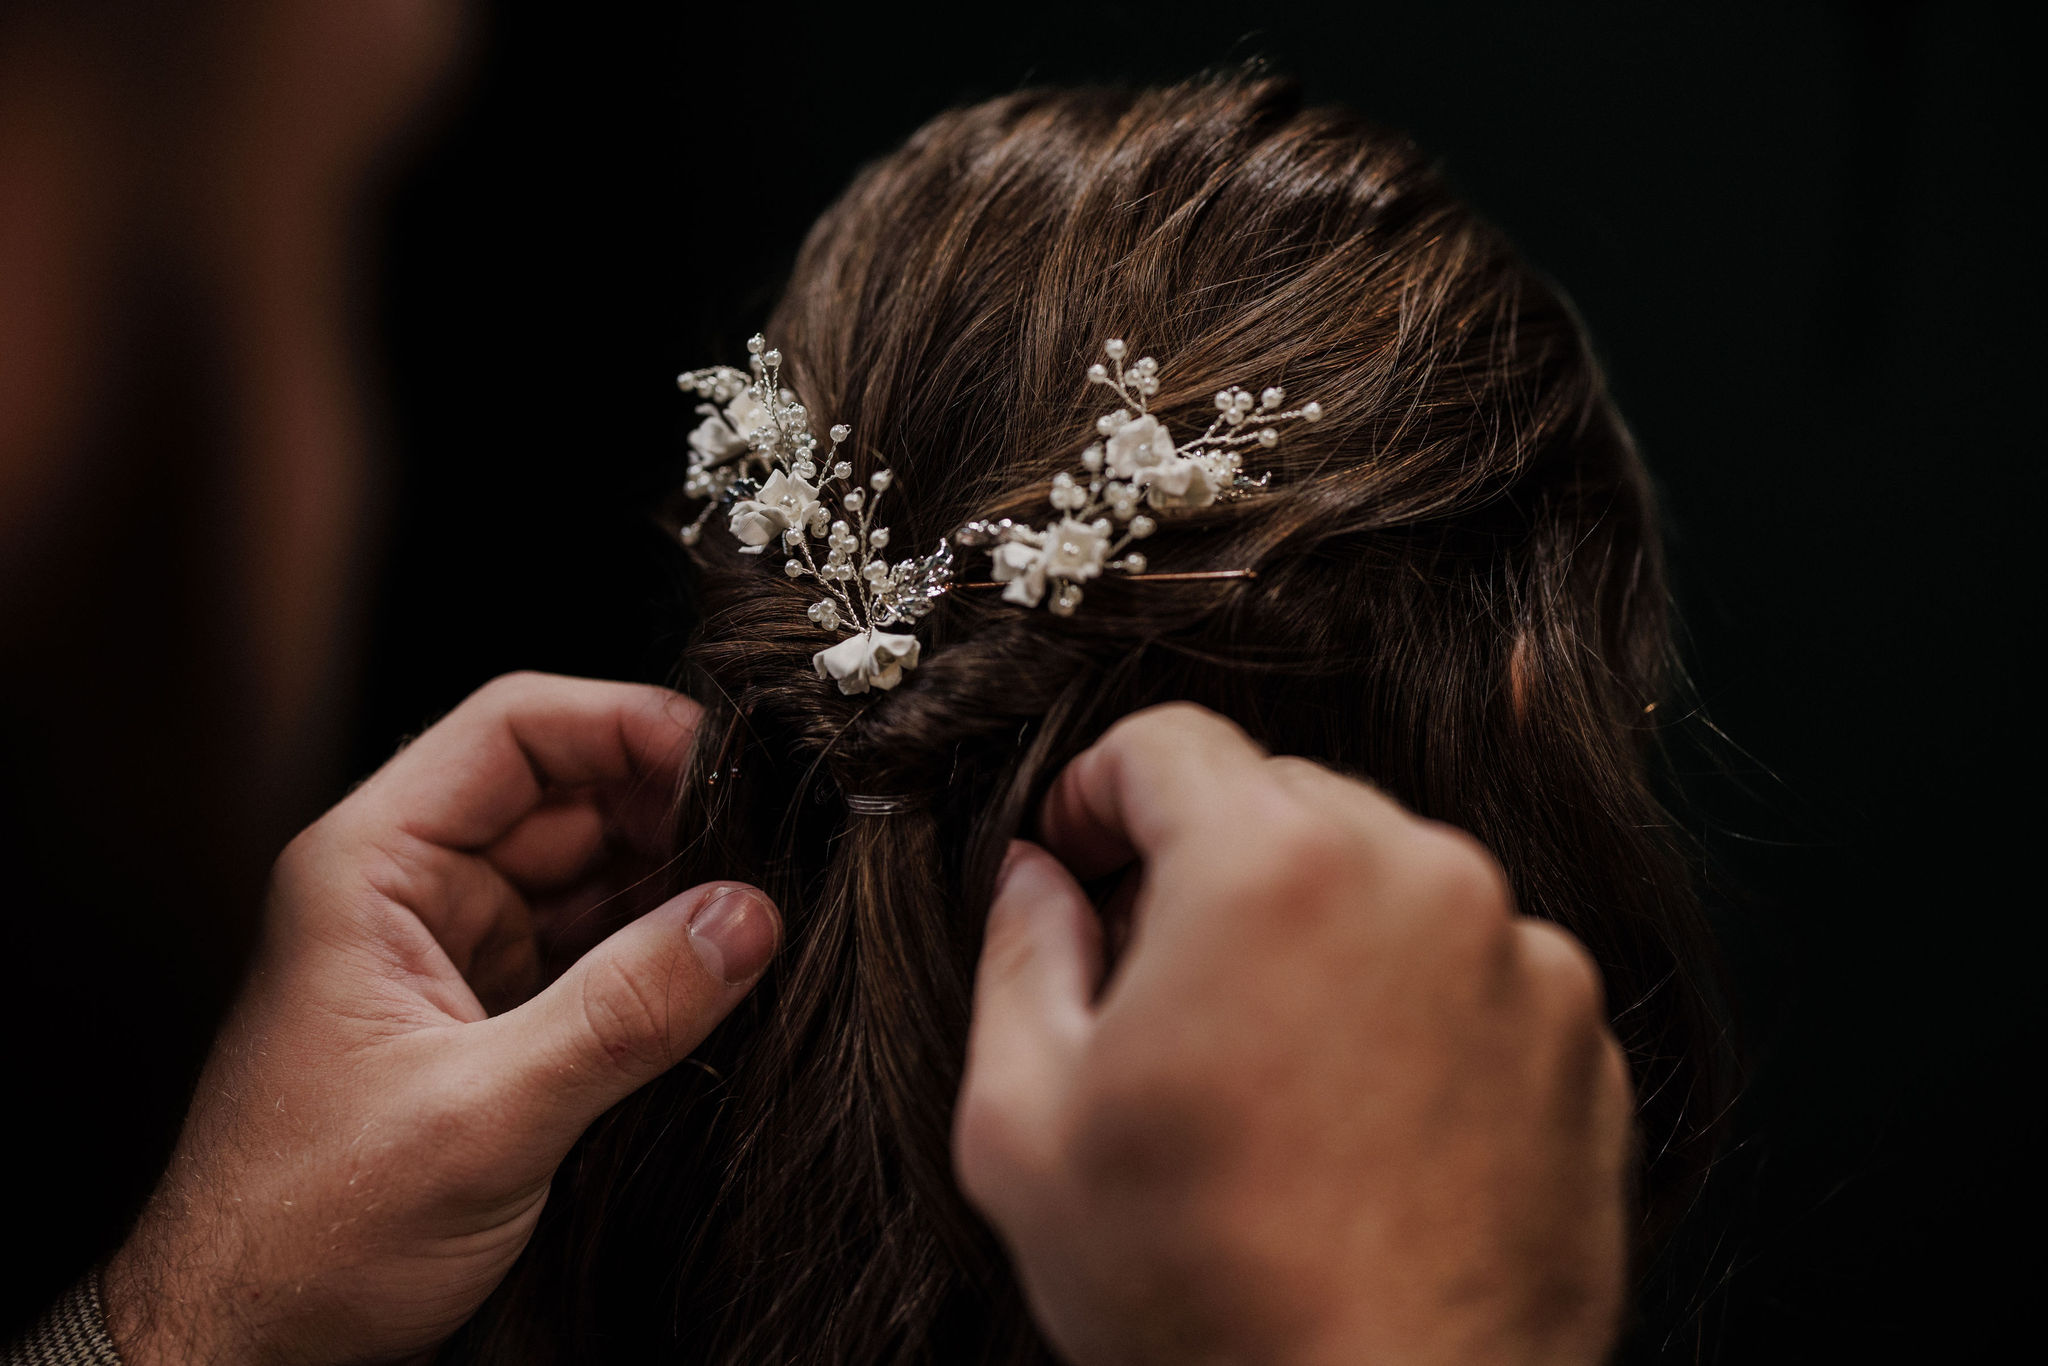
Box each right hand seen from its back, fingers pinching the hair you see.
[954,705,1630,1366]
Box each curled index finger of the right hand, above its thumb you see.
[1038,702,1268,881]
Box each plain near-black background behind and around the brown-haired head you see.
[18,2,2044,1362]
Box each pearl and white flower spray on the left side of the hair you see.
[676,336,952,694]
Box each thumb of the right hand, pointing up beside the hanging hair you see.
[952,840,1102,1214]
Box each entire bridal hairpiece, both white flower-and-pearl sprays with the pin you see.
[676,336,1323,694]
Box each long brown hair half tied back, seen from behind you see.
[453,76,1720,1364]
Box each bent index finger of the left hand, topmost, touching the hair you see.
[348,674,702,850]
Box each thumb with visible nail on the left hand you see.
[475,883,782,1157]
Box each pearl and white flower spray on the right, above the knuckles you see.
[952,338,1323,616]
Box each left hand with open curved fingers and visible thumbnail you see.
[104,676,780,1366]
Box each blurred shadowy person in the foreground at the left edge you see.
[0,0,459,1335]
